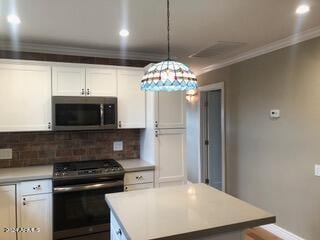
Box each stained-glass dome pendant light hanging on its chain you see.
[141,0,198,91]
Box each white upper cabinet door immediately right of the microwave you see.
[118,69,146,128]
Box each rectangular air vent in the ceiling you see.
[189,41,245,59]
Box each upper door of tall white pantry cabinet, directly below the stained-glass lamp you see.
[156,92,186,128]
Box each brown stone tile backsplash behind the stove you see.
[0,129,140,168]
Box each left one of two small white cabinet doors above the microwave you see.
[52,67,86,96]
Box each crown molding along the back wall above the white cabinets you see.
[0,41,166,61]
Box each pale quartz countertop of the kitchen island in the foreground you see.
[106,184,275,240]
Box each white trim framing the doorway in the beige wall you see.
[198,82,226,192]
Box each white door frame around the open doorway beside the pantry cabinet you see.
[199,82,226,192]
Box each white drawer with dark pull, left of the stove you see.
[20,180,52,196]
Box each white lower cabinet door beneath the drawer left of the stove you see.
[20,194,52,240]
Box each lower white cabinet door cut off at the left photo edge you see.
[0,185,16,240]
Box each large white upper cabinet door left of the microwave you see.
[0,64,51,131]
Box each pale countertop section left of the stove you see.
[0,165,53,184]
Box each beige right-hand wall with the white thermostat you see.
[199,38,320,240]
